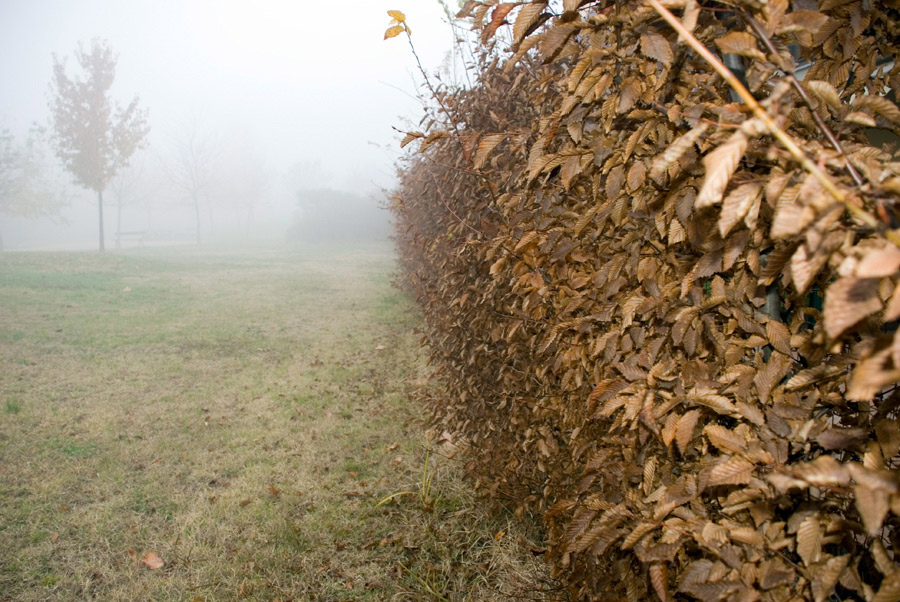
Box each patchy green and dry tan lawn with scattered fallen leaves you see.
[0,246,550,601]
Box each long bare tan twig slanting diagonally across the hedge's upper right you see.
[647,0,900,247]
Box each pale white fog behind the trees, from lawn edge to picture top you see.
[0,0,455,249]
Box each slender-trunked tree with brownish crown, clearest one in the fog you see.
[50,39,149,251]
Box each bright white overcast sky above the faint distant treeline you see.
[0,0,455,191]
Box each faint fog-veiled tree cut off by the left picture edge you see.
[0,129,63,250]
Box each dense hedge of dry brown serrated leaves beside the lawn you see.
[393,0,900,602]
